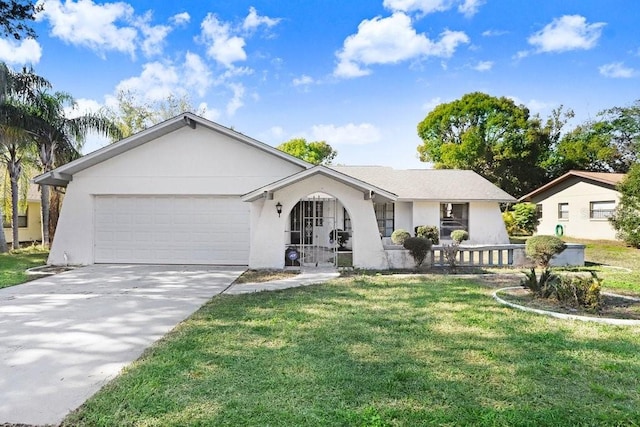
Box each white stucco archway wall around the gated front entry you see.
[249,175,388,269]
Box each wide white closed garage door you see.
[94,196,249,265]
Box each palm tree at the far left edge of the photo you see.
[0,63,49,252]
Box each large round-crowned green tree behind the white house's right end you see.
[418,92,552,197]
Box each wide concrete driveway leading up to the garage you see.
[0,265,243,424]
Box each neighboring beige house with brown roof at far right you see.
[520,170,625,240]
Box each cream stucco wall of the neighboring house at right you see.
[532,178,620,240]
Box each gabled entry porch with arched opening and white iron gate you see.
[243,166,396,269]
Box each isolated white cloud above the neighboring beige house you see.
[528,15,606,52]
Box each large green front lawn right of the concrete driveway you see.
[65,275,640,426]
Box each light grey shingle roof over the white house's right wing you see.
[331,166,515,202]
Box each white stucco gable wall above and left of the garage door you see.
[49,126,302,264]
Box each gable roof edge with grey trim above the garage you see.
[33,113,313,186]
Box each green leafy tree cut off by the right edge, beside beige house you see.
[609,163,640,248]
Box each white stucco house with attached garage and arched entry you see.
[35,113,515,269]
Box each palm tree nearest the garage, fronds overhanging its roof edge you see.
[31,90,120,246]
